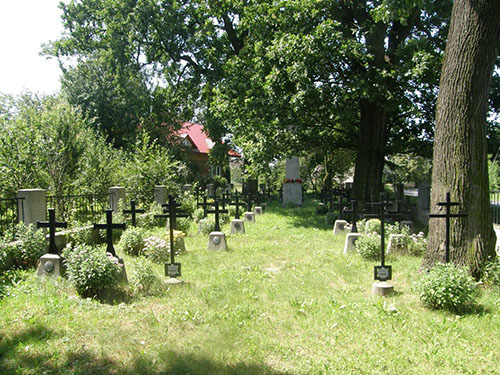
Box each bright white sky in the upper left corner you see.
[0,0,68,95]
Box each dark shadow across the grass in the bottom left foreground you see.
[0,334,291,375]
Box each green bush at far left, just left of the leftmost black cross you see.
[4,223,48,269]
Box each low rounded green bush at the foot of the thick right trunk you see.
[415,263,479,312]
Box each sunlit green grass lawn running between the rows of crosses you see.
[0,198,500,375]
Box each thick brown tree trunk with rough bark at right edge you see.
[423,0,500,277]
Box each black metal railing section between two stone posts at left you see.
[47,193,113,223]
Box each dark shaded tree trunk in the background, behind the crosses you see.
[352,100,387,201]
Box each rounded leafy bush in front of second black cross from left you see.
[63,245,123,298]
